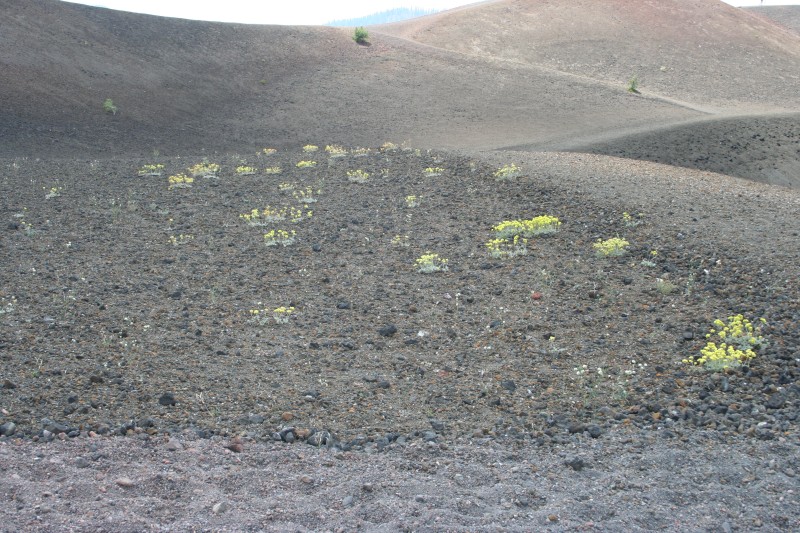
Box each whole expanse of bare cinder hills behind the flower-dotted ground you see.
[0,0,800,186]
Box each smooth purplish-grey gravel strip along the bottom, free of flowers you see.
[0,430,800,532]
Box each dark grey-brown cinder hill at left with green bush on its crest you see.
[0,0,698,155]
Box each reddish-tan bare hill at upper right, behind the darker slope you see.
[377,0,800,108]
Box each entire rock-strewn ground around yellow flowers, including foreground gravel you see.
[0,144,800,530]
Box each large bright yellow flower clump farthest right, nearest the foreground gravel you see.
[683,315,769,371]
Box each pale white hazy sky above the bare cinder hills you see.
[62,0,800,24]
